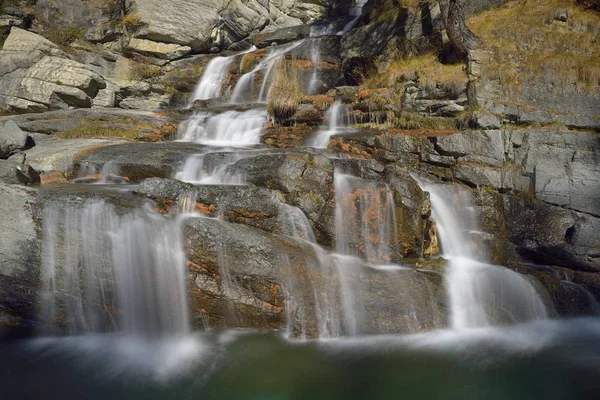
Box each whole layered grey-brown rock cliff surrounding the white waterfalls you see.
[0,0,600,336]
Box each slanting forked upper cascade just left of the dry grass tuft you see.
[231,40,304,104]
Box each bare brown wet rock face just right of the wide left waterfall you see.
[184,218,317,329]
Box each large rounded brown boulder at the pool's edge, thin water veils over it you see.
[184,218,447,337]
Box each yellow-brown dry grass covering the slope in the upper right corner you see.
[468,0,600,90]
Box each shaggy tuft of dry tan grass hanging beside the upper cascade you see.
[267,63,304,122]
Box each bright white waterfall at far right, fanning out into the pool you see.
[421,183,546,329]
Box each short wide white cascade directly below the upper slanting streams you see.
[177,110,267,146]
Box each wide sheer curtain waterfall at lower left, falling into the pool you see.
[40,200,190,337]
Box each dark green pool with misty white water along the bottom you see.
[0,319,600,400]
